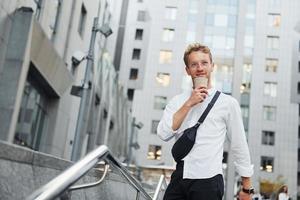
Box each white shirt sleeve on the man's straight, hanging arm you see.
[227,98,253,177]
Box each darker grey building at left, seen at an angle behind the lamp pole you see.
[0,0,131,160]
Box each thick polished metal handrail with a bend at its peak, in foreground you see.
[26,145,152,200]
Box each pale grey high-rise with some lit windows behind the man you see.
[120,0,300,200]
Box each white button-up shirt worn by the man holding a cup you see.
[157,88,253,179]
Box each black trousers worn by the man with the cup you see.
[164,162,224,200]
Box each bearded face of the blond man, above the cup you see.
[185,51,214,80]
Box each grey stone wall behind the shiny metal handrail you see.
[0,142,149,200]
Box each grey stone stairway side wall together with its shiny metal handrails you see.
[0,142,166,200]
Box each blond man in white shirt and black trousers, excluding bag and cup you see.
[157,43,253,200]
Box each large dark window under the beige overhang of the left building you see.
[14,65,50,150]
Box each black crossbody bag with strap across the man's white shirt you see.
[172,91,221,162]
